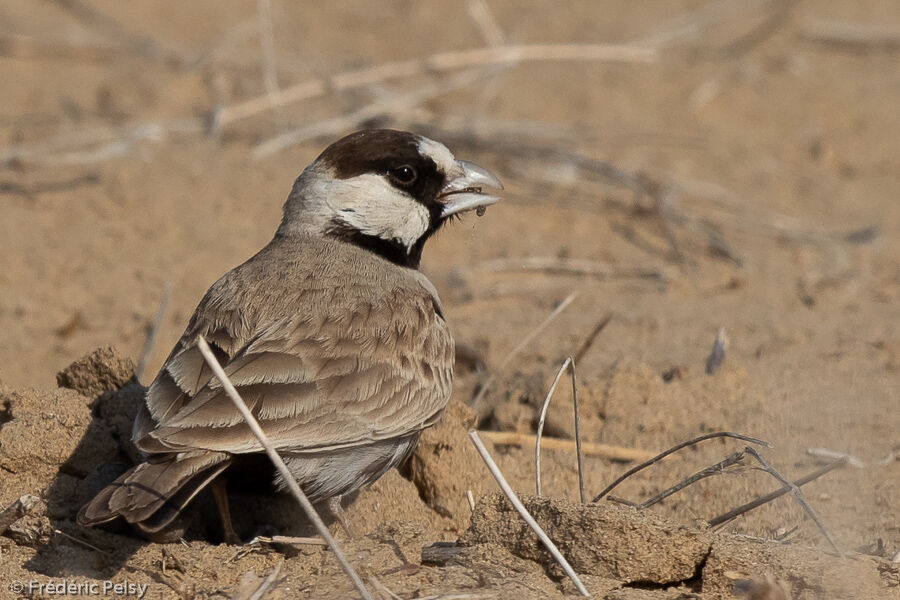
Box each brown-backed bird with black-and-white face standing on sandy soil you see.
[77,129,503,543]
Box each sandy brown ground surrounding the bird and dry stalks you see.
[0,0,900,599]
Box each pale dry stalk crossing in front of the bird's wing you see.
[197,335,374,600]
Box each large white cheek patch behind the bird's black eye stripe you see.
[325,174,431,251]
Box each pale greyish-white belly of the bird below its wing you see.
[275,432,419,502]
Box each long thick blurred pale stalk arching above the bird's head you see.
[213,44,656,131]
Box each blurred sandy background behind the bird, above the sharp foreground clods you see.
[0,0,900,564]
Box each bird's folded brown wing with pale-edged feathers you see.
[137,286,453,453]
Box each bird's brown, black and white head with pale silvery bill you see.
[278,129,503,268]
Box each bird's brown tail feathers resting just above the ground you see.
[78,451,231,533]
